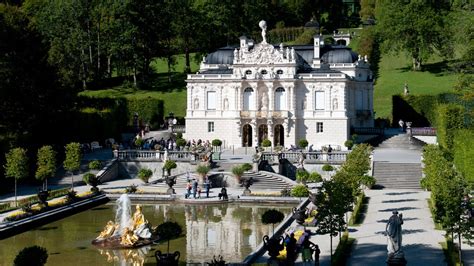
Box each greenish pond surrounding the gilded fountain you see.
[0,203,294,265]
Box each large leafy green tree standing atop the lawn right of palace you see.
[377,0,451,71]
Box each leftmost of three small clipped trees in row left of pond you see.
[4,148,28,206]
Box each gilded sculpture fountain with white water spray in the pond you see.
[92,194,158,249]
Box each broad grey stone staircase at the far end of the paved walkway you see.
[374,161,422,189]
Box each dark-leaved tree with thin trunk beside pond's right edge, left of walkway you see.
[313,180,352,263]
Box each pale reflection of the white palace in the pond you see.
[184,205,289,262]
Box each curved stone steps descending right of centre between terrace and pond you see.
[242,171,296,191]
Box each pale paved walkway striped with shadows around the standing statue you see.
[349,189,446,266]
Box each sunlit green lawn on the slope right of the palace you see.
[374,54,456,118]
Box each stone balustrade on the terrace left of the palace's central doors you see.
[114,150,198,162]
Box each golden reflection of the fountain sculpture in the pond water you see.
[99,246,151,266]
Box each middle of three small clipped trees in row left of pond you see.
[35,145,56,190]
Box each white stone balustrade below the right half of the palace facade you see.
[262,151,349,164]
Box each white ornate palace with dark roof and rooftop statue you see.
[185,21,373,149]
